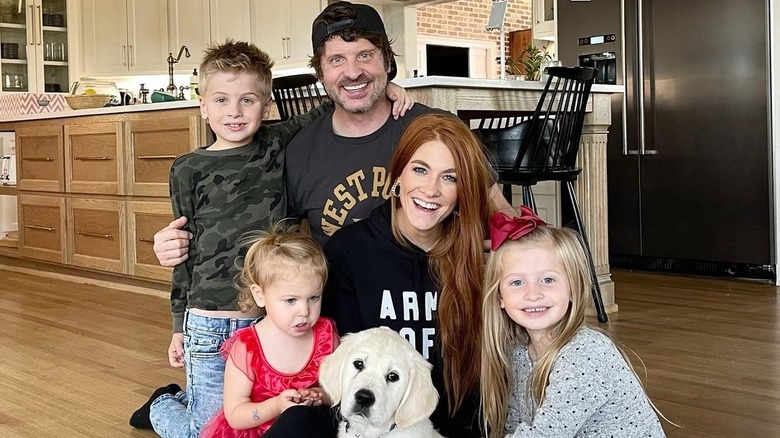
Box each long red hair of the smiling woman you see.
[390,114,493,415]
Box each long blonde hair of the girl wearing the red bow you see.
[481,226,591,437]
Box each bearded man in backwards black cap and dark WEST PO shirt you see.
[154,1,515,256]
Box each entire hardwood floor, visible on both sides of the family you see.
[0,270,780,438]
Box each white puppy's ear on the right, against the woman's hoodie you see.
[395,351,439,427]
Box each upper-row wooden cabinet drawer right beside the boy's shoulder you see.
[126,115,200,196]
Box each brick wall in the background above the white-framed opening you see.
[417,0,531,62]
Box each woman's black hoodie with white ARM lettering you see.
[322,201,481,438]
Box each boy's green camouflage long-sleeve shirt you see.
[170,102,333,333]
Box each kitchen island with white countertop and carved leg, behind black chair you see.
[395,76,623,313]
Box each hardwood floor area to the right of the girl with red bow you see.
[602,271,780,438]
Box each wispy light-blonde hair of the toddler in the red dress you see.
[235,220,328,312]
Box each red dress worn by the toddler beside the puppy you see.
[200,317,338,438]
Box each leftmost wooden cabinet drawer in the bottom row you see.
[19,195,66,263]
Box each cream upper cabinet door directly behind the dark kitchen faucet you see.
[168,0,211,72]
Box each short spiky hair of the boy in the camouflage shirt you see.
[198,38,274,99]
